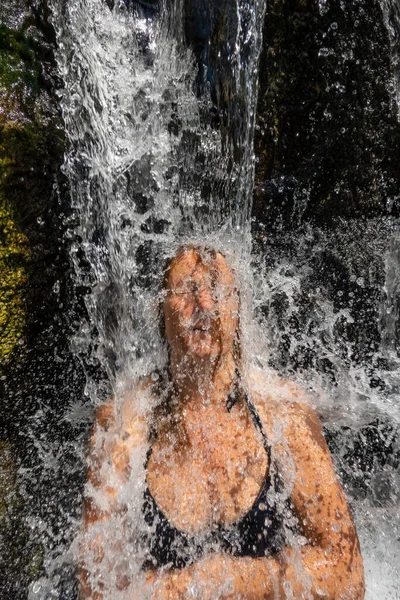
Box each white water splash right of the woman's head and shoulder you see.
[252,219,400,600]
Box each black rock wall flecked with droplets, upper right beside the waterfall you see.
[254,0,400,228]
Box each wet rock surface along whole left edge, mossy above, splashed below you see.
[0,0,83,600]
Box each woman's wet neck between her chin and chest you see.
[170,352,237,410]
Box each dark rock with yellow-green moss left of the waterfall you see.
[0,0,65,374]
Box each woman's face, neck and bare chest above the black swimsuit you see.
[147,251,268,533]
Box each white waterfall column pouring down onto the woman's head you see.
[53,0,264,392]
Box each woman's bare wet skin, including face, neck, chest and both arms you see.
[81,249,364,600]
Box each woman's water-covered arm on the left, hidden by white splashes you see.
[78,399,147,600]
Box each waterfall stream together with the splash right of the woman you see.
[25,0,400,600]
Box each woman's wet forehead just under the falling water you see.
[168,249,234,285]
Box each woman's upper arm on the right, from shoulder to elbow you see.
[282,403,365,600]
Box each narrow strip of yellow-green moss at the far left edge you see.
[0,2,40,374]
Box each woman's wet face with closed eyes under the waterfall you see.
[163,249,239,358]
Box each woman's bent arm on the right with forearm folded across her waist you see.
[148,403,364,600]
